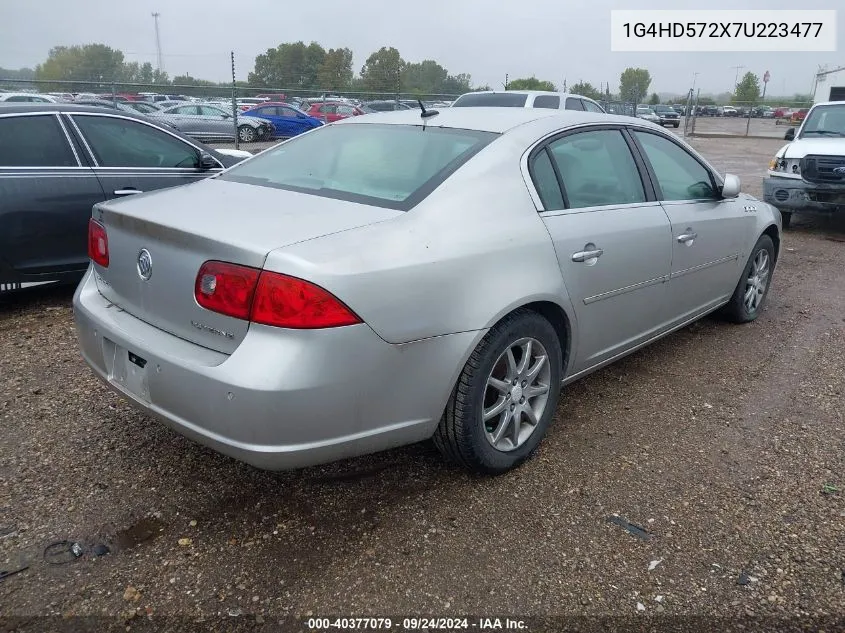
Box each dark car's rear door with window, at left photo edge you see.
[0,113,104,275]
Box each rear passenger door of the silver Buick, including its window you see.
[531,128,672,374]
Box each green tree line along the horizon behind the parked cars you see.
[0,41,812,104]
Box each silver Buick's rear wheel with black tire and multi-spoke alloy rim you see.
[432,309,562,475]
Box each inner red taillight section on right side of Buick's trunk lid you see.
[194,261,261,319]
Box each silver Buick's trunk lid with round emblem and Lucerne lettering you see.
[94,179,402,353]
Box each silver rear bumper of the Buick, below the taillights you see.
[73,271,479,470]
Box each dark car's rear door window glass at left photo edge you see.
[0,114,78,167]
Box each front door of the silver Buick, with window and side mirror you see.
[632,130,754,321]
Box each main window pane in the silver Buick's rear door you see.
[549,130,645,209]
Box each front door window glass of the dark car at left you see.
[73,115,199,168]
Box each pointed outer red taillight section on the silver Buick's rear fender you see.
[250,270,361,330]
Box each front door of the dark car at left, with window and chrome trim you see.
[65,114,222,199]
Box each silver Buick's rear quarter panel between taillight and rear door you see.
[265,136,571,343]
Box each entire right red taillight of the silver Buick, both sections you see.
[194,261,361,329]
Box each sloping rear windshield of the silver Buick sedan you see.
[219,123,498,211]
